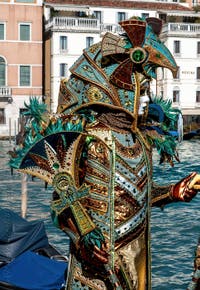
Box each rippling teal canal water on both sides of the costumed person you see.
[0,140,200,290]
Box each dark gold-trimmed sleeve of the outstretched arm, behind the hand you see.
[151,183,174,207]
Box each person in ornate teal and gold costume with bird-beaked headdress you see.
[10,18,200,290]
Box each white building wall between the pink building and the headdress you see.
[44,6,161,112]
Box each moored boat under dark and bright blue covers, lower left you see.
[0,209,68,290]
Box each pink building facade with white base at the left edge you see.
[0,1,43,136]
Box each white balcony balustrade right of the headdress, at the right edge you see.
[162,22,200,35]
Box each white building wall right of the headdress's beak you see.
[157,24,200,115]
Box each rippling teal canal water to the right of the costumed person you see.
[151,140,200,290]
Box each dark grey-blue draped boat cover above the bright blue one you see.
[0,208,49,263]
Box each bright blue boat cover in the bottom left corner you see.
[0,251,67,290]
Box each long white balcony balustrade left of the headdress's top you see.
[45,17,122,33]
